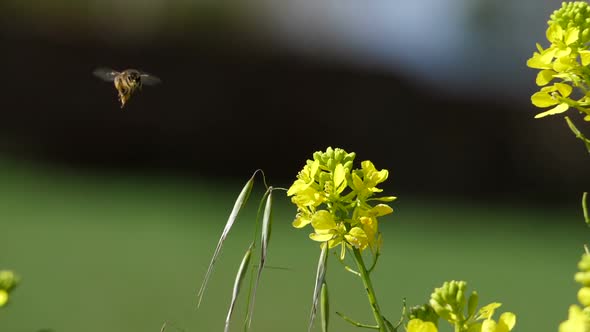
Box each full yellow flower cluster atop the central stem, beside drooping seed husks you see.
[287,148,395,258]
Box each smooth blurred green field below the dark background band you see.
[0,160,587,332]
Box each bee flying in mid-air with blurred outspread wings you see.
[93,68,161,108]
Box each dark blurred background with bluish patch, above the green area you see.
[0,0,590,201]
